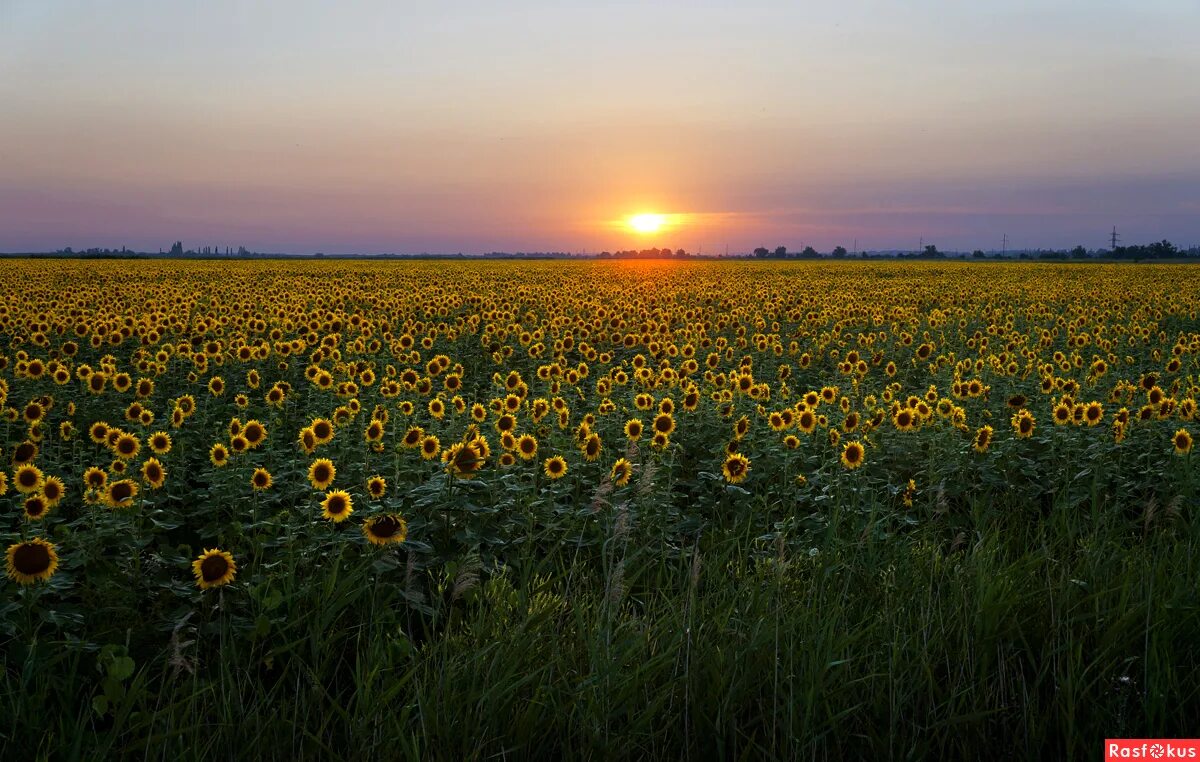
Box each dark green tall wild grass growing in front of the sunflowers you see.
[0,475,1200,760]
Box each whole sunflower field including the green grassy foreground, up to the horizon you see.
[0,260,1200,760]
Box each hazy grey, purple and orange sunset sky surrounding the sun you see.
[0,0,1200,253]
